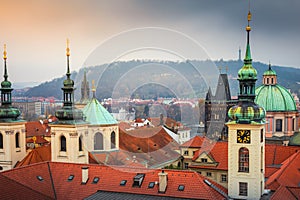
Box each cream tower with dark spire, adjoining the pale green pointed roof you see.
[50,41,89,163]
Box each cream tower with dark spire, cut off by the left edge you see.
[0,45,26,171]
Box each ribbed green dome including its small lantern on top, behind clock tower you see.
[255,64,297,112]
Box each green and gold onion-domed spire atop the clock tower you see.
[228,12,266,124]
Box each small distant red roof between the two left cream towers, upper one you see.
[25,121,51,137]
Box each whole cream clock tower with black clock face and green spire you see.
[226,11,265,199]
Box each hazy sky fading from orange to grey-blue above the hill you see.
[0,0,300,82]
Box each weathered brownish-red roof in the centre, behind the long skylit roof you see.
[93,127,180,167]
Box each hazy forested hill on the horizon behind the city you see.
[23,60,300,100]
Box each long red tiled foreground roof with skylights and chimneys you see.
[0,162,227,199]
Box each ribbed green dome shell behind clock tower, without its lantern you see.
[255,84,297,112]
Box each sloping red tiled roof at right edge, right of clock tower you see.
[266,151,300,190]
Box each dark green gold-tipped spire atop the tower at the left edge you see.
[0,45,21,122]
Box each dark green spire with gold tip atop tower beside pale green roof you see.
[55,40,84,124]
